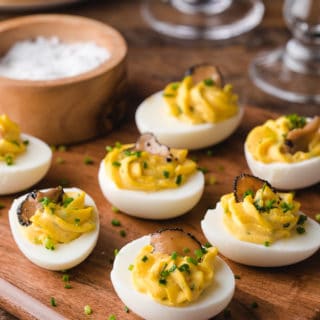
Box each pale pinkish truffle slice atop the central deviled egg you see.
[135,133,173,161]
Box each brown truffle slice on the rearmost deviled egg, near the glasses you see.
[185,63,224,87]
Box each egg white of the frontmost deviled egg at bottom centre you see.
[111,235,235,320]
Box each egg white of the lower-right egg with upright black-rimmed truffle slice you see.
[201,202,320,267]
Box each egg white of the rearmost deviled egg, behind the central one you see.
[135,91,244,150]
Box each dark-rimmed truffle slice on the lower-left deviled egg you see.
[17,187,64,226]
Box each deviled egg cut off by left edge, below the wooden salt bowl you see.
[0,114,52,195]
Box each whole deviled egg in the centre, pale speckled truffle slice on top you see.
[99,134,204,219]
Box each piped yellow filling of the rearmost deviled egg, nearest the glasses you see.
[163,76,239,124]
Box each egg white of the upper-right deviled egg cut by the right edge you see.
[244,144,320,190]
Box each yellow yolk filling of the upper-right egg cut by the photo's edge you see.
[246,116,320,163]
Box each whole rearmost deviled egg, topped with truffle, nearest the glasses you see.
[135,64,243,150]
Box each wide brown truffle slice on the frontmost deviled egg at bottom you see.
[150,228,202,257]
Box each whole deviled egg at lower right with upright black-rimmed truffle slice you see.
[201,174,320,267]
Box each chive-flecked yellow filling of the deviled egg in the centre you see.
[104,144,197,191]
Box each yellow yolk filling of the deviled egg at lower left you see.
[21,192,96,250]
